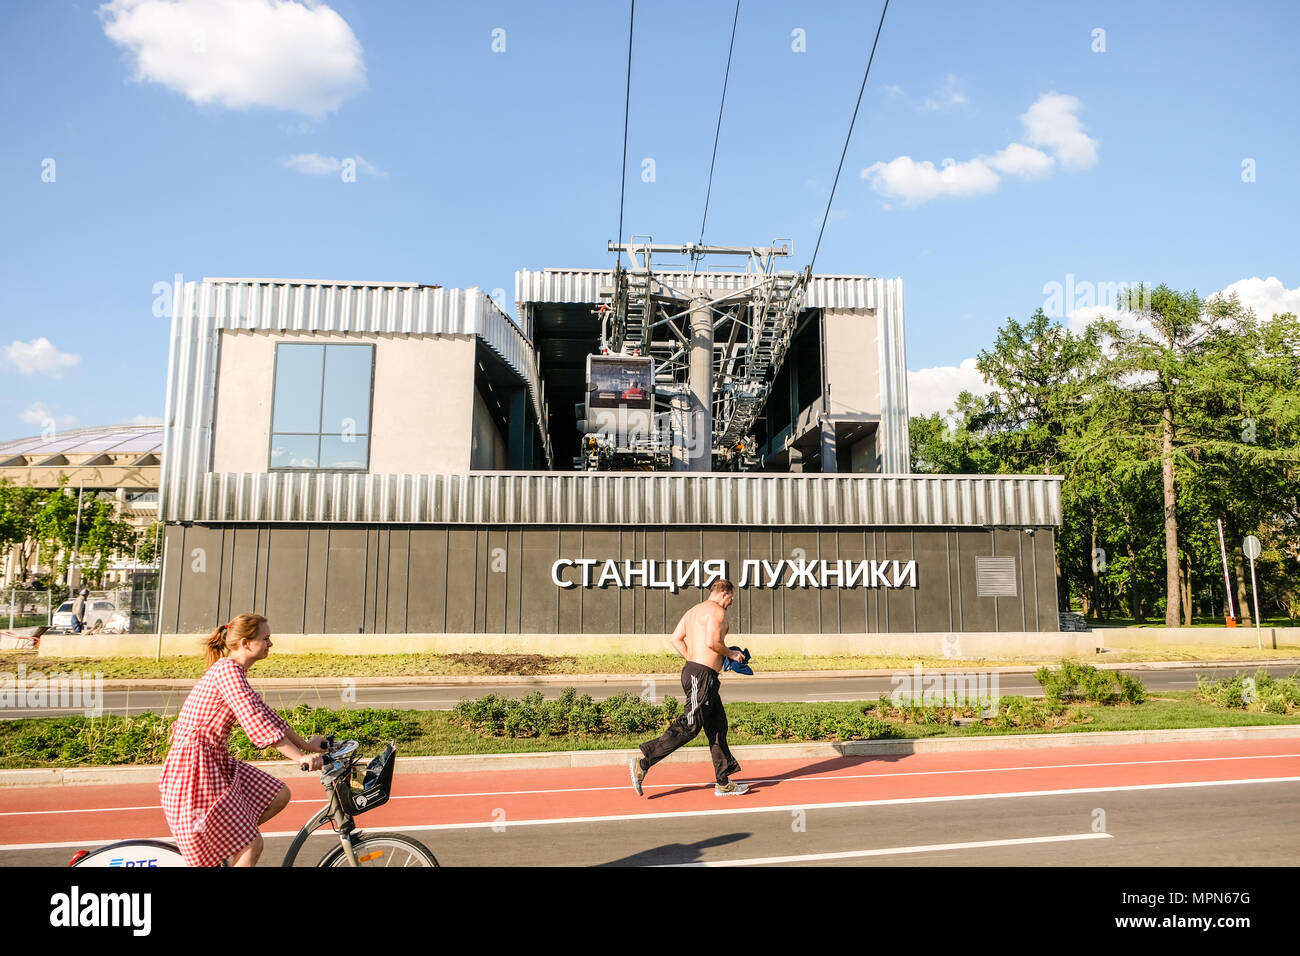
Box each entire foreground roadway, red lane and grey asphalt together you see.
[0,739,1300,868]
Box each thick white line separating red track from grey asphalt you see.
[0,777,1300,853]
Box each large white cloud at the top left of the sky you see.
[99,0,365,117]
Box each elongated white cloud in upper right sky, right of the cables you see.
[862,92,1097,206]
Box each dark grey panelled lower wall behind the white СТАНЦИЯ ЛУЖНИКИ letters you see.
[163,525,1057,633]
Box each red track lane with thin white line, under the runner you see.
[0,739,1300,848]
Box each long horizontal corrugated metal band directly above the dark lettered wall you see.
[165,472,1061,528]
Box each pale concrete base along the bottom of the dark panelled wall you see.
[39,631,1105,661]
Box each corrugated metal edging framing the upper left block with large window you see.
[160,281,551,520]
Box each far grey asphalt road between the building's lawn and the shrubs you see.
[0,665,1296,718]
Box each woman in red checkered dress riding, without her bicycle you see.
[159,614,322,866]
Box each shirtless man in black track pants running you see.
[628,580,749,796]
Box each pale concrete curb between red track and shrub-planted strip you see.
[0,724,1300,788]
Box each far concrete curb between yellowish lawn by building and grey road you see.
[31,658,1300,691]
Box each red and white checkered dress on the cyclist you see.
[159,657,289,866]
